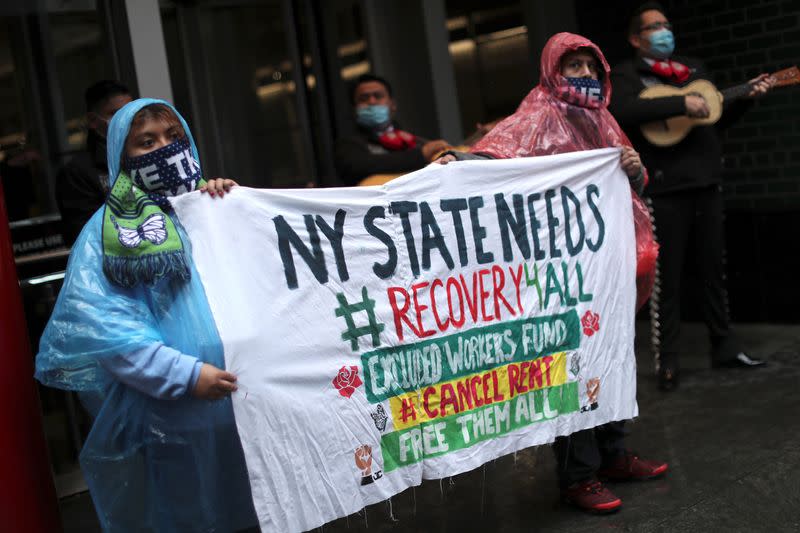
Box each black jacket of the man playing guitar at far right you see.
[609,57,748,196]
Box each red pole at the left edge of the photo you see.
[0,183,62,533]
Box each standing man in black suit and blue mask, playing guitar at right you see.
[609,2,773,390]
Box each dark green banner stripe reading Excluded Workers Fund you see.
[361,309,581,403]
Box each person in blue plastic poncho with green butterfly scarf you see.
[36,99,257,532]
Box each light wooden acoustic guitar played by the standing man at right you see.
[639,66,800,146]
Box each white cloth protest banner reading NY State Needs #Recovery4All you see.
[174,149,637,531]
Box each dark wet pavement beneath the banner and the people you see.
[61,322,800,533]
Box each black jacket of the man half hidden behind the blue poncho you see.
[56,130,109,246]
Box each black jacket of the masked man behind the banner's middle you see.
[336,124,428,185]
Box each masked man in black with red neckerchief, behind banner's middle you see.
[336,74,449,185]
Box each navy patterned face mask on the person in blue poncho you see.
[122,138,201,207]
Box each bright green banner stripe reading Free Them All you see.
[381,381,579,472]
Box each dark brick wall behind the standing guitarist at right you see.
[575,0,800,322]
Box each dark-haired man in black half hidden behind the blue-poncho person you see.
[56,80,132,246]
